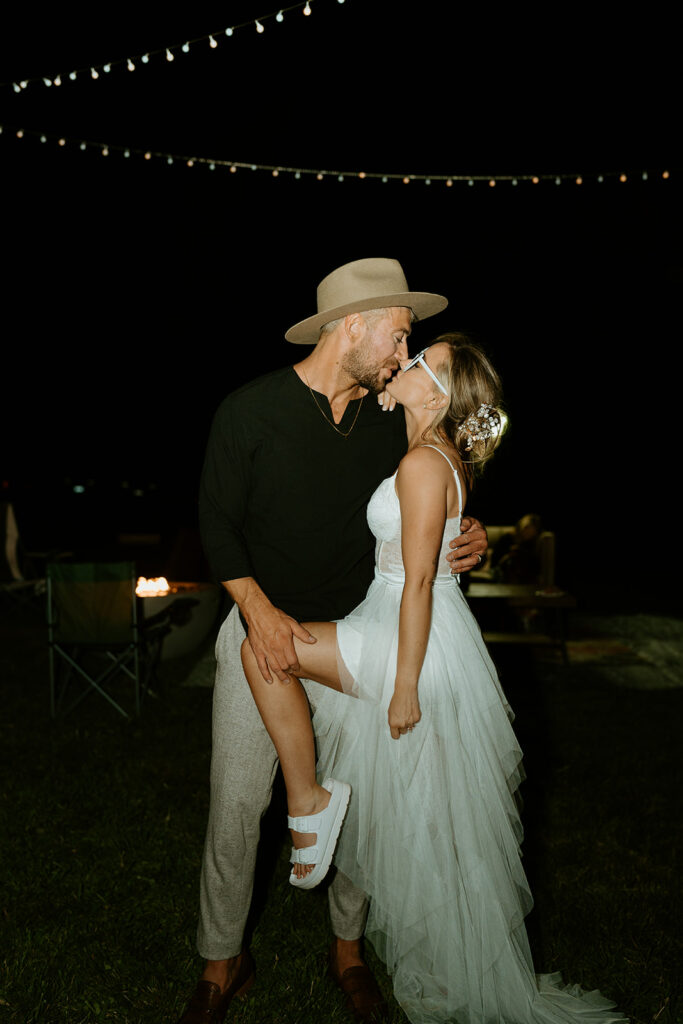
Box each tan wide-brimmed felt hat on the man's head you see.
[285,259,449,345]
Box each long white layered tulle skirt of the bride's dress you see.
[313,575,625,1024]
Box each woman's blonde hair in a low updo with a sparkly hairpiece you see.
[423,332,505,482]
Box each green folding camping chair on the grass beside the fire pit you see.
[47,562,166,718]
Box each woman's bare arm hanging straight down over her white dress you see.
[389,449,449,739]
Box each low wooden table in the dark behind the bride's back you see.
[465,581,577,663]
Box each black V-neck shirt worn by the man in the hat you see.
[200,367,407,621]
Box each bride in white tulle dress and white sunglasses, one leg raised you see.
[243,336,624,1024]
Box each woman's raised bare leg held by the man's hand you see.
[242,623,341,878]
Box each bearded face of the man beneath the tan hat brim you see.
[344,306,411,394]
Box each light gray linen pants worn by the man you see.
[197,607,368,959]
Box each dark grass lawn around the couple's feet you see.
[0,602,683,1024]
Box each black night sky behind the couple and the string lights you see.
[0,0,683,610]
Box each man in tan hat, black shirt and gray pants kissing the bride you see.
[178,259,486,1024]
